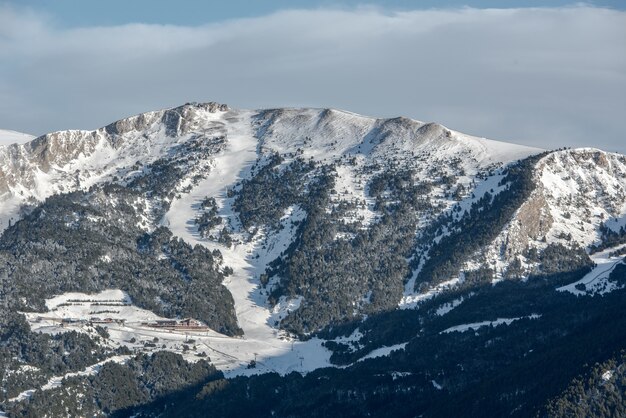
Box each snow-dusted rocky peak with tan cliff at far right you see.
[485,148,626,277]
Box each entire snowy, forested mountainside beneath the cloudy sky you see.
[0,103,626,416]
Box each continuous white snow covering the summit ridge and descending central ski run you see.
[0,103,540,372]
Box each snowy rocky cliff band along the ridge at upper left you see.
[0,102,228,228]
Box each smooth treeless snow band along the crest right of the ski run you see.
[256,109,541,166]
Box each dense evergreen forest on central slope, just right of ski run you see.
[253,165,432,335]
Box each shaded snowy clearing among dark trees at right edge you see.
[556,245,626,296]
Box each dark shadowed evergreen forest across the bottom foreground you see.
[8,264,626,417]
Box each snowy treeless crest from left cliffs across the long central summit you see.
[0,103,538,226]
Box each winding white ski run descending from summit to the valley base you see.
[162,111,331,375]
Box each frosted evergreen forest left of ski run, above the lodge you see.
[0,185,241,335]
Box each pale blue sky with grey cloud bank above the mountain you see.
[0,0,626,153]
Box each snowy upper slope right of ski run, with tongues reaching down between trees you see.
[255,109,543,248]
